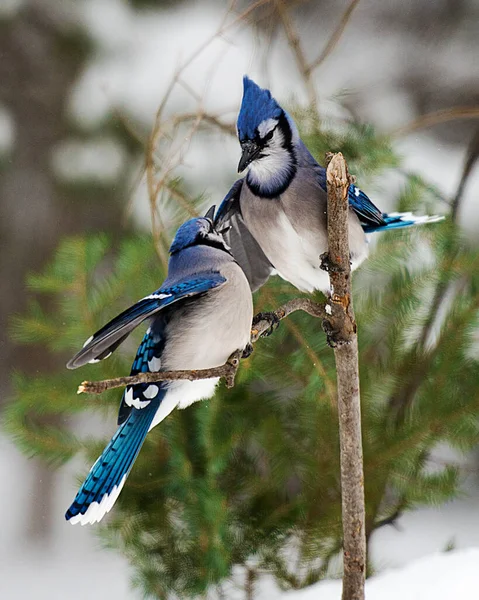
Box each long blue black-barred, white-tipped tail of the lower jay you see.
[65,395,161,525]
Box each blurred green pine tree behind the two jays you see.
[6,115,479,598]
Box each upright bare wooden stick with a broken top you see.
[323,153,366,600]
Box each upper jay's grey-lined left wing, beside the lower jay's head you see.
[214,179,273,292]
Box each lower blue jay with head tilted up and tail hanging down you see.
[65,207,253,525]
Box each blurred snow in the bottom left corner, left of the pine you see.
[0,435,135,600]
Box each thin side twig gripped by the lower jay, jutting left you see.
[77,298,327,394]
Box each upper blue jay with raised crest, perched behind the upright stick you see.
[215,76,442,293]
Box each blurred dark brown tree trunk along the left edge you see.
[0,3,128,536]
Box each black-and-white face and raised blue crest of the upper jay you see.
[237,75,298,192]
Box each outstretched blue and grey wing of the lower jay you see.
[67,271,226,369]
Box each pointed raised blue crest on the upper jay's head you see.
[237,75,283,141]
